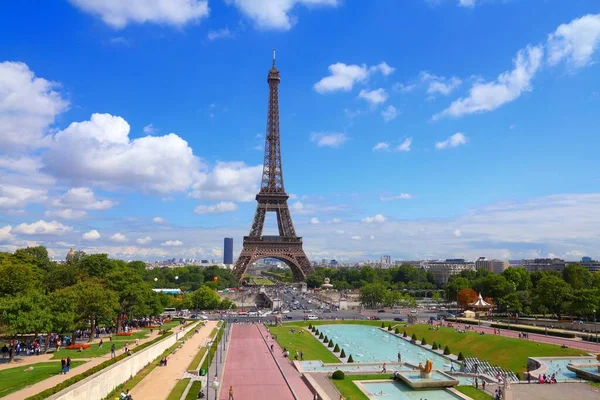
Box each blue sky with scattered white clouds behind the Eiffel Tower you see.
[0,0,600,261]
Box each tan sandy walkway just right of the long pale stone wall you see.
[131,321,217,400]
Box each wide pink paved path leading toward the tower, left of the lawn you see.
[219,325,294,400]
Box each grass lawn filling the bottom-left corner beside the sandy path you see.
[0,361,85,397]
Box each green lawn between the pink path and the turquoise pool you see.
[268,325,340,363]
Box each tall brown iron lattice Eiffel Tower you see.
[233,50,313,282]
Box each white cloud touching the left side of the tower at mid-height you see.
[189,162,263,201]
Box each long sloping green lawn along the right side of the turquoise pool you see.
[400,325,587,372]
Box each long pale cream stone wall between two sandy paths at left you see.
[48,324,198,400]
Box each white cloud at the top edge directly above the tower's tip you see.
[225,0,339,31]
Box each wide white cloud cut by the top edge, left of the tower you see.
[69,0,209,29]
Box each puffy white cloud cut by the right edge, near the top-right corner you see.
[548,14,600,68]
